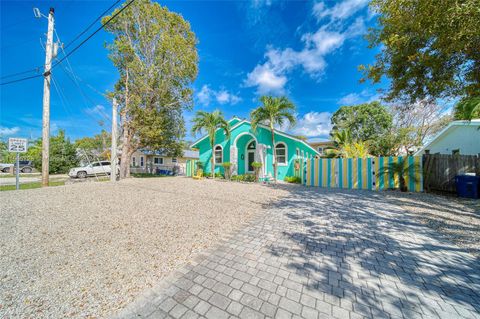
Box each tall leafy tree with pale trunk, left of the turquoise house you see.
[102,0,198,177]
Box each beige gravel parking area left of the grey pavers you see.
[0,178,285,318]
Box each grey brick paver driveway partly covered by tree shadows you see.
[118,187,480,318]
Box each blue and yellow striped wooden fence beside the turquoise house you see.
[303,156,423,192]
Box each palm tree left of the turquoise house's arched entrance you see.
[192,110,230,178]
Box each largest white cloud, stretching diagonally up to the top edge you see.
[244,0,366,94]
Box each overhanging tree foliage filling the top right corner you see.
[360,0,480,103]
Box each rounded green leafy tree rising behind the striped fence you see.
[330,101,393,156]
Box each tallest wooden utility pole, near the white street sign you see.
[42,8,55,187]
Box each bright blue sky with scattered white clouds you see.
[0,0,379,140]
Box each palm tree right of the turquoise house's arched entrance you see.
[250,96,296,182]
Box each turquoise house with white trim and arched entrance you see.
[191,117,319,180]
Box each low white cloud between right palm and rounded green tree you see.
[292,112,332,137]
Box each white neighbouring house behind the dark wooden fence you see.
[415,119,480,155]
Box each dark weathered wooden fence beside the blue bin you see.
[423,154,480,192]
